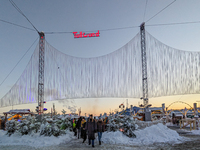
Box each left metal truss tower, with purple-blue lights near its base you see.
[38,32,45,114]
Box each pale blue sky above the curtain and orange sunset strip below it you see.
[0,0,200,114]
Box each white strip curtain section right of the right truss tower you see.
[146,32,200,97]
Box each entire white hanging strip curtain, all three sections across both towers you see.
[0,32,200,107]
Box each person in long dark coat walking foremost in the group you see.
[85,115,97,147]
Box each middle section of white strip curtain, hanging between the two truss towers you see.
[45,34,142,100]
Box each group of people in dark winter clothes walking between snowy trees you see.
[72,115,107,147]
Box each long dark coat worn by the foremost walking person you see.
[85,119,97,140]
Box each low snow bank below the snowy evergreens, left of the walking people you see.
[0,130,75,147]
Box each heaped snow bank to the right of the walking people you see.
[102,123,182,145]
